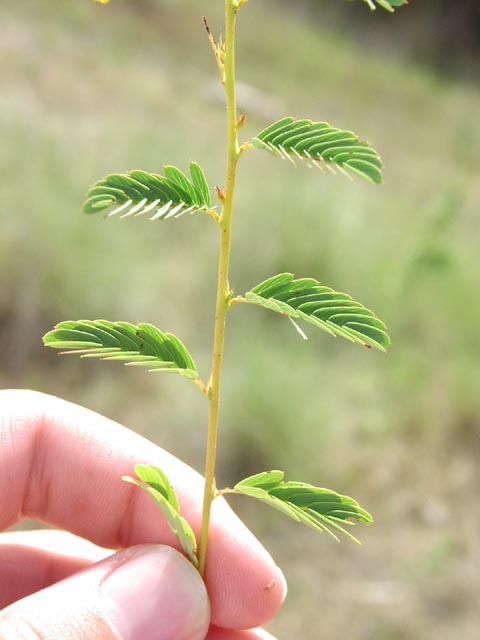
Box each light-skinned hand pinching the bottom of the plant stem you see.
[0,391,286,640]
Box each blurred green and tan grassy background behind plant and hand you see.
[0,0,480,640]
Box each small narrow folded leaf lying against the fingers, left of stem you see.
[122,464,198,566]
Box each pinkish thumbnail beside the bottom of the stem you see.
[100,545,209,640]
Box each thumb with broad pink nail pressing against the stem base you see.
[0,545,210,640]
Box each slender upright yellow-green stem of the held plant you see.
[198,0,240,575]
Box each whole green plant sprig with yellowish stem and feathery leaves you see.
[38,0,405,574]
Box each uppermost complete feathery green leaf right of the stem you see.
[252,117,383,184]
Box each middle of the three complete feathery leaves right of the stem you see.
[244,273,390,351]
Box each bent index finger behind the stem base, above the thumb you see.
[0,391,285,629]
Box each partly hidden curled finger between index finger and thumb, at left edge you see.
[0,530,113,609]
